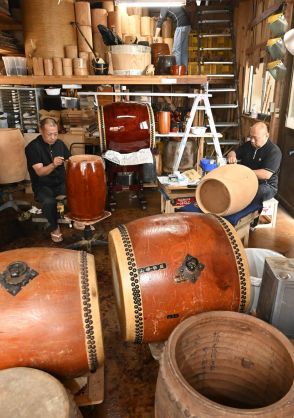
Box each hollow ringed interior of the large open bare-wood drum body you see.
[174,314,294,409]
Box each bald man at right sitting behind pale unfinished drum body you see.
[227,122,282,204]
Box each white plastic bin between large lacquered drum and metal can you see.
[245,248,284,314]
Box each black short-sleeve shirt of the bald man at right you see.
[236,139,282,189]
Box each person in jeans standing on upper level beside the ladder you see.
[155,7,191,71]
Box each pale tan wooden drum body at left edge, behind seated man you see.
[0,128,27,184]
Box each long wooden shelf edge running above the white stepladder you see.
[0,75,207,86]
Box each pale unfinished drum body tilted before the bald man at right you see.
[196,164,258,216]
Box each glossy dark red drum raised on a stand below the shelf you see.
[98,102,155,153]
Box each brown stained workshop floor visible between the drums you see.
[0,189,294,418]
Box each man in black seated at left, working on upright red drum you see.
[25,118,70,242]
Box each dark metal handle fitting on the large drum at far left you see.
[0,261,38,296]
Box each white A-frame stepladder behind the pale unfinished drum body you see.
[173,93,223,173]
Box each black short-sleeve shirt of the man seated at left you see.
[25,135,70,194]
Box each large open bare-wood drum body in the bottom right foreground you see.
[155,312,294,418]
